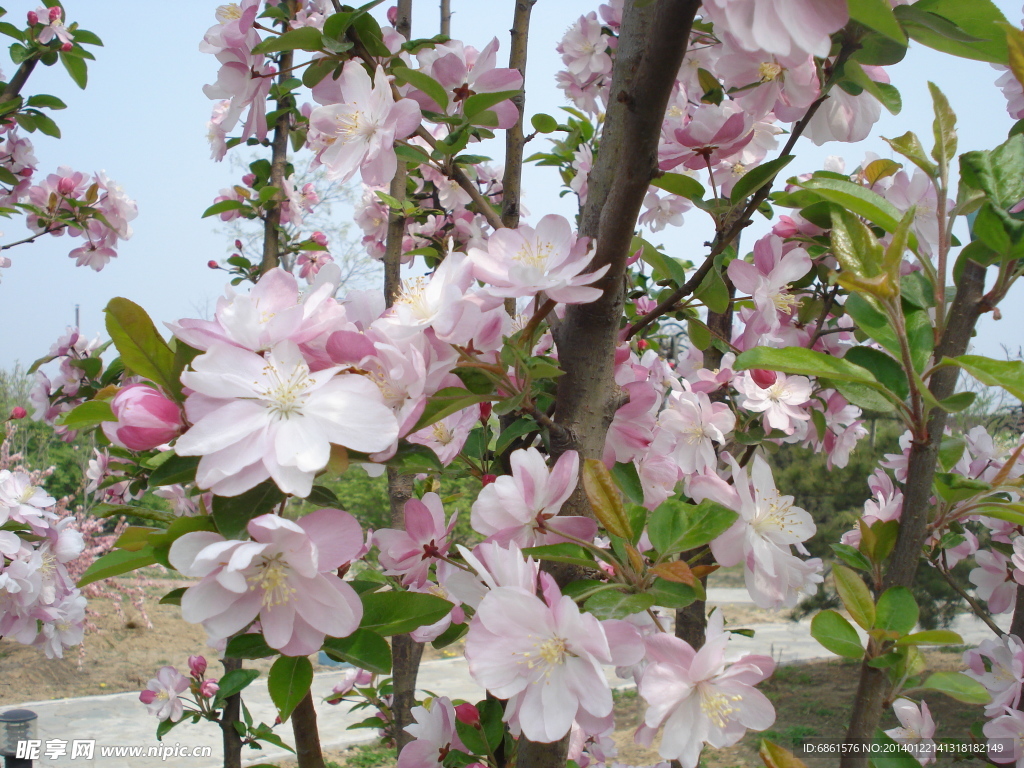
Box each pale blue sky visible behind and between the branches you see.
[0,0,1024,369]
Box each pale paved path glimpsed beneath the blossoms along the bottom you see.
[5,589,1009,768]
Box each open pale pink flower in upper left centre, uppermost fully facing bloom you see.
[309,60,420,184]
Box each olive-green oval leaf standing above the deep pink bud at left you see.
[103,298,181,398]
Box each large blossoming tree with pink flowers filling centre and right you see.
[14,0,1024,768]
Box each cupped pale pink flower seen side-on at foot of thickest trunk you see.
[470,447,597,547]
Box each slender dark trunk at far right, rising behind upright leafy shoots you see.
[841,261,985,768]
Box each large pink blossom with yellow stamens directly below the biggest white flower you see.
[169,509,362,656]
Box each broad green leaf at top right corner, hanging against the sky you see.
[894,0,1010,65]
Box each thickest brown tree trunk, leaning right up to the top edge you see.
[517,6,700,768]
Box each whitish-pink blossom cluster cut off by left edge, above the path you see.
[0,436,86,658]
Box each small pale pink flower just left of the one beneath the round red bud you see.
[657,391,736,474]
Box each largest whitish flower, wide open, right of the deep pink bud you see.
[175,341,398,497]
